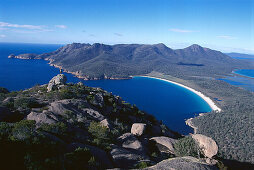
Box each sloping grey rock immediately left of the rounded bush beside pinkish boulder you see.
[150,136,177,154]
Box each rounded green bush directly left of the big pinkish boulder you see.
[174,136,200,158]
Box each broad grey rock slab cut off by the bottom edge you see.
[145,156,218,170]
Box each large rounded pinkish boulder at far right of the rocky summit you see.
[191,134,218,158]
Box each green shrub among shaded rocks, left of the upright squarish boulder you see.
[88,121,110,147]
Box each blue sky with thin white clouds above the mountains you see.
[0,0,254,54]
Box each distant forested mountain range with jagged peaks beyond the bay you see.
[11,43,253,79]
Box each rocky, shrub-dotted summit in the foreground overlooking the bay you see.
[0,74,220,169]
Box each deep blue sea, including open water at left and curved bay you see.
[0,43,252,134]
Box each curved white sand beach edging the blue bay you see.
[136,76,221,112]
